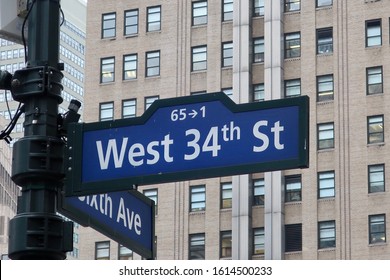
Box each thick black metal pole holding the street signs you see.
[8,0,73,260]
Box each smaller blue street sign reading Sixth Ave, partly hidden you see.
[58,190,155,259]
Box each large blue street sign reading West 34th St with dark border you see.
[66,93,309,195]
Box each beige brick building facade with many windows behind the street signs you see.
[79,0,390,260]
